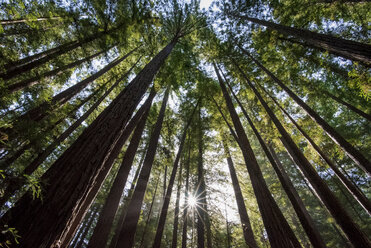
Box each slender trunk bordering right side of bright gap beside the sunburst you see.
[223,140,258,248]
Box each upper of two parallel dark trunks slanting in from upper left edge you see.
[0,29,115,80]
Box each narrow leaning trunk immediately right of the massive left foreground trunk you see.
[61,88,156,248]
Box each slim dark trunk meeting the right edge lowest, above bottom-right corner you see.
[262,85,371,215]
